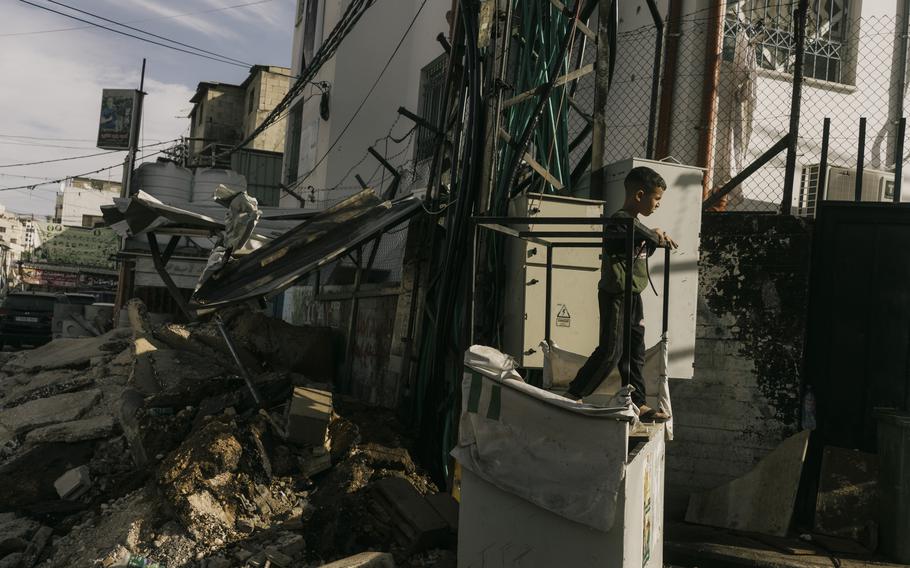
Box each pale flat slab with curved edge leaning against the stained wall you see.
[686,430,809,536]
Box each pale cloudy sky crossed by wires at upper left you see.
[0,0,296,215]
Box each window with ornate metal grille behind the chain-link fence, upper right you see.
[723,0,853,84]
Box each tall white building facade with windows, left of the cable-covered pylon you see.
[283,0,451,209]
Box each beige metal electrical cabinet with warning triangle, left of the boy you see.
[503,193,603,368]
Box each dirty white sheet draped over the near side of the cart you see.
[452,346,634,531]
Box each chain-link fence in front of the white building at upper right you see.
[588,6,903,216]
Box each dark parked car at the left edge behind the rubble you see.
[0,292,59,348]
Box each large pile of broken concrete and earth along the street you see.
[0,303,457,568]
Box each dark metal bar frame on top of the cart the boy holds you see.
[474,216,670,377]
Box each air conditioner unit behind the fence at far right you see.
[799,164,894,217]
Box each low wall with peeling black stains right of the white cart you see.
[667,214,811,515]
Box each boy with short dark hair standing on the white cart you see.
[565,167,677,421]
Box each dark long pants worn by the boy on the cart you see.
[569,290,645,406]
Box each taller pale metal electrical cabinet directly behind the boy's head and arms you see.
[604,158,704,379]
